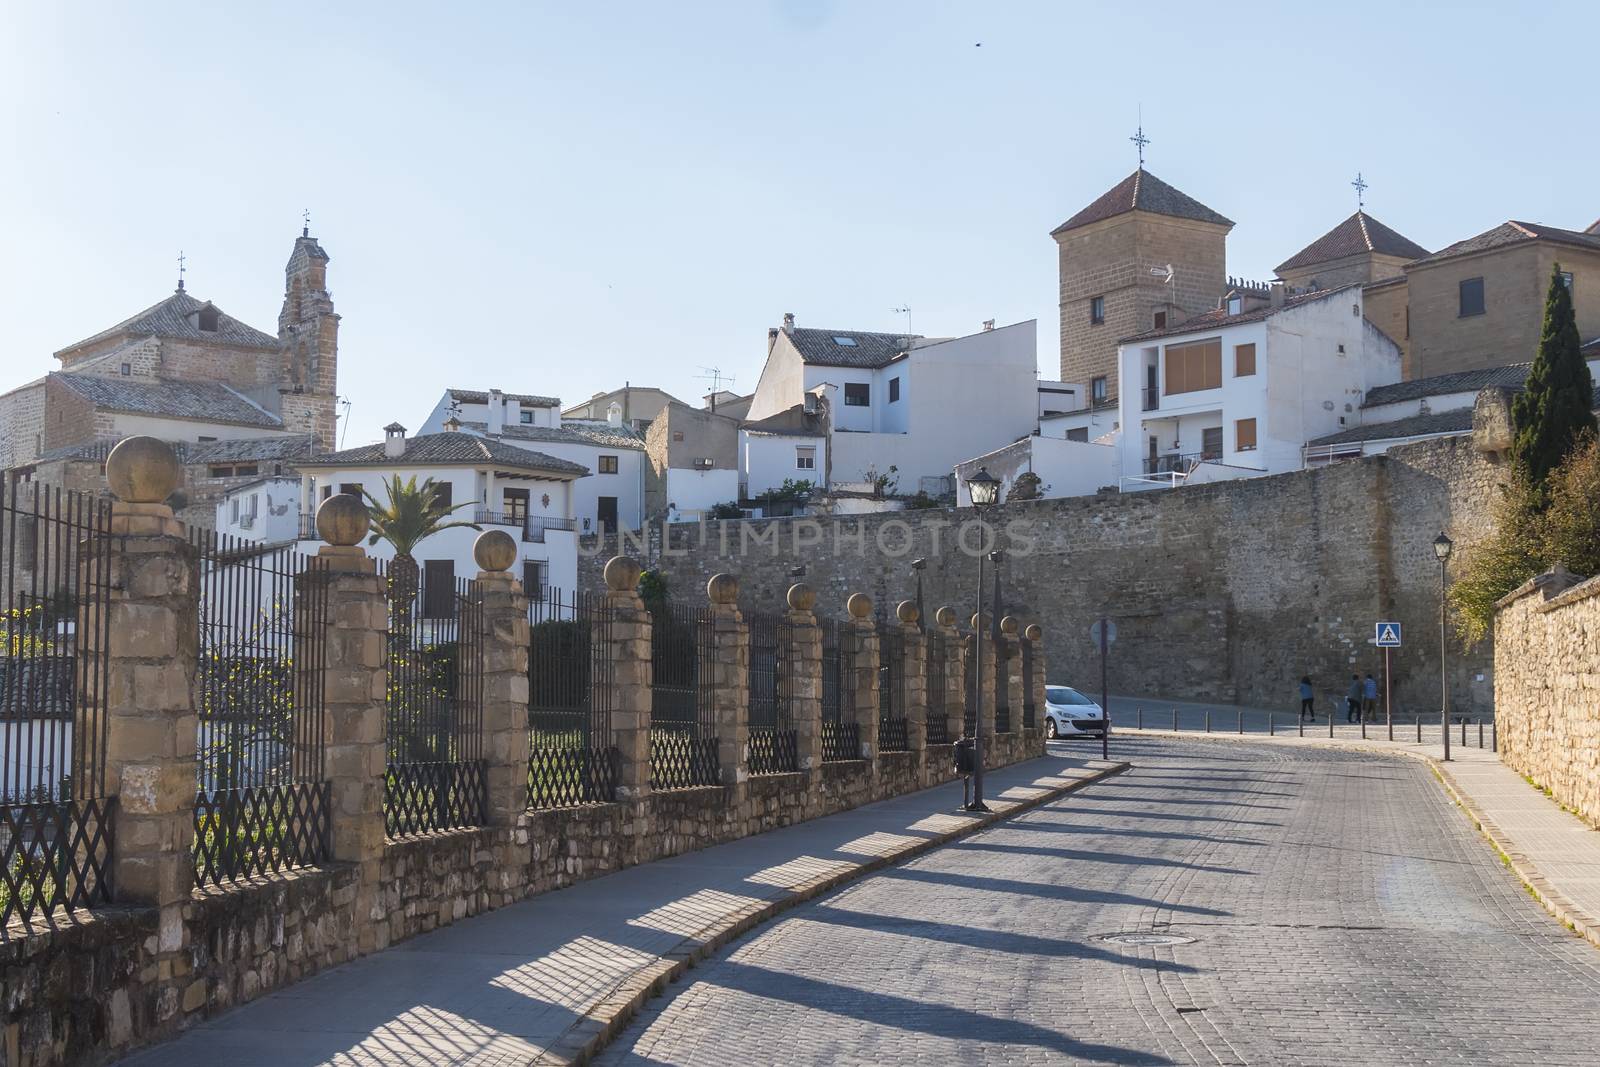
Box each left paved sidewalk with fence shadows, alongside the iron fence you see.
[123,752,1126,1067]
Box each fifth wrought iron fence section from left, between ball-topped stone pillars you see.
[650,601,722,789]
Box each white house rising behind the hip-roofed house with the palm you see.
[422,389,650,533]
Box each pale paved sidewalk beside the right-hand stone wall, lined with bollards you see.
[1110,696,1600,947]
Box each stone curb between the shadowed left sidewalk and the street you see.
[528,761,1131,1067]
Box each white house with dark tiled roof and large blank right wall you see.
[741,315,1040,498]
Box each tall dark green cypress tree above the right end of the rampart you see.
[1510,264,1595,504]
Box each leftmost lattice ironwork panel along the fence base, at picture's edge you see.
[0,797,115,928]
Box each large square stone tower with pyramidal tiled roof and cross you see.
[1050,166,1234,402]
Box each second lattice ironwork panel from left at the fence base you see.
[195,782,330,885]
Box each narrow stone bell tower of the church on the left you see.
[278,227,339,450]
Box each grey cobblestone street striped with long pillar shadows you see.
[602,737,1600,1064]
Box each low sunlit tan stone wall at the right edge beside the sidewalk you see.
[1494,571,1600,829]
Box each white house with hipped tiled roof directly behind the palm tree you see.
[298,424,589,597]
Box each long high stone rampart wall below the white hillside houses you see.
[579,437,1504,715]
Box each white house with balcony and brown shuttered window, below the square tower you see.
[1118,285,1400,490]
